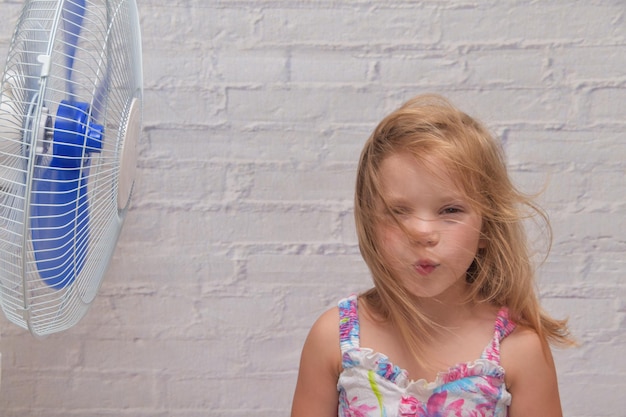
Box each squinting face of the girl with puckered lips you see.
[377,152,483,301]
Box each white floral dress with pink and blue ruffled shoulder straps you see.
[337,296,515,417]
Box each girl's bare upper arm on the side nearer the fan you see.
[291,308,341,417]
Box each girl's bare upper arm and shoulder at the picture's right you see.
[501,328,563,417]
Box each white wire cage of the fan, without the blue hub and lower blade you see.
[0,0,143,336]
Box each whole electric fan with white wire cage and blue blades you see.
[0,0,143,336]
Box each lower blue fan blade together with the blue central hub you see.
[31,100,104,289]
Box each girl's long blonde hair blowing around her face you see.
[355,95,573,361]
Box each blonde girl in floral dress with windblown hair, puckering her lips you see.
[291,95,572,417]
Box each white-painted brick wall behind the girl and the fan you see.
[0,0,626,417]
